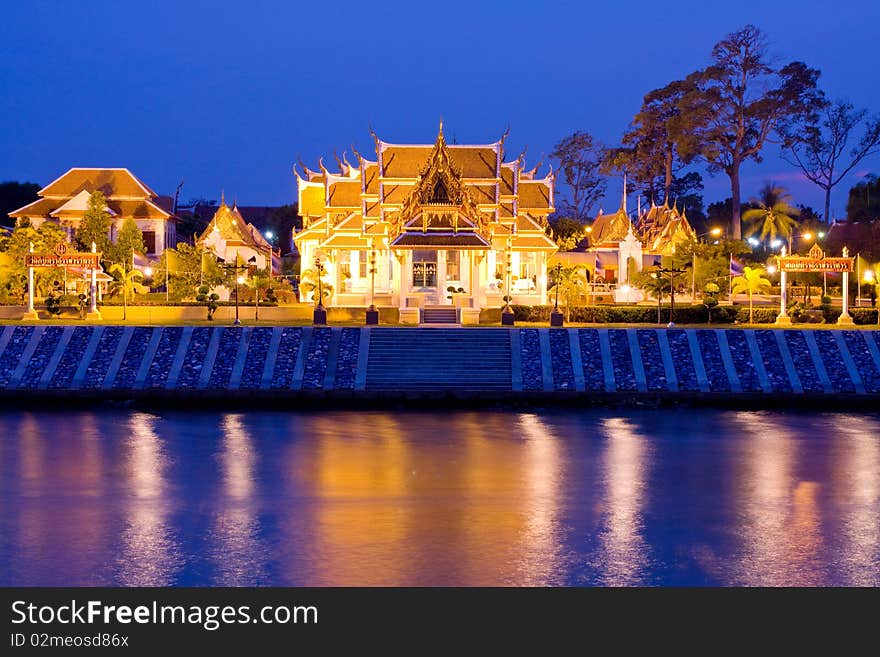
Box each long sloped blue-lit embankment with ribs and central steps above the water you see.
[0,324,880,408]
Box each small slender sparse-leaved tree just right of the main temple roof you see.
[550,131,606,223]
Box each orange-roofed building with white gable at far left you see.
[9,167,178,256]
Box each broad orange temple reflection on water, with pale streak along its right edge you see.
[285,414,562,585]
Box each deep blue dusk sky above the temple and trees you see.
[0,0,880,218]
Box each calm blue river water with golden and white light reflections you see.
[0,410,880,585]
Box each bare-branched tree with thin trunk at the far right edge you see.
[783,100,880,222]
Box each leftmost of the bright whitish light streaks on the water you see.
[117,413,182,586]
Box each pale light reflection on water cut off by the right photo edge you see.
[833,418,880,586]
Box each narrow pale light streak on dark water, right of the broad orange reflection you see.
[595,417,648,586]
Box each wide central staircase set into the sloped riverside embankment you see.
[366,328,511,392]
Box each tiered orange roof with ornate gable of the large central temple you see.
[294,123,556,251]
